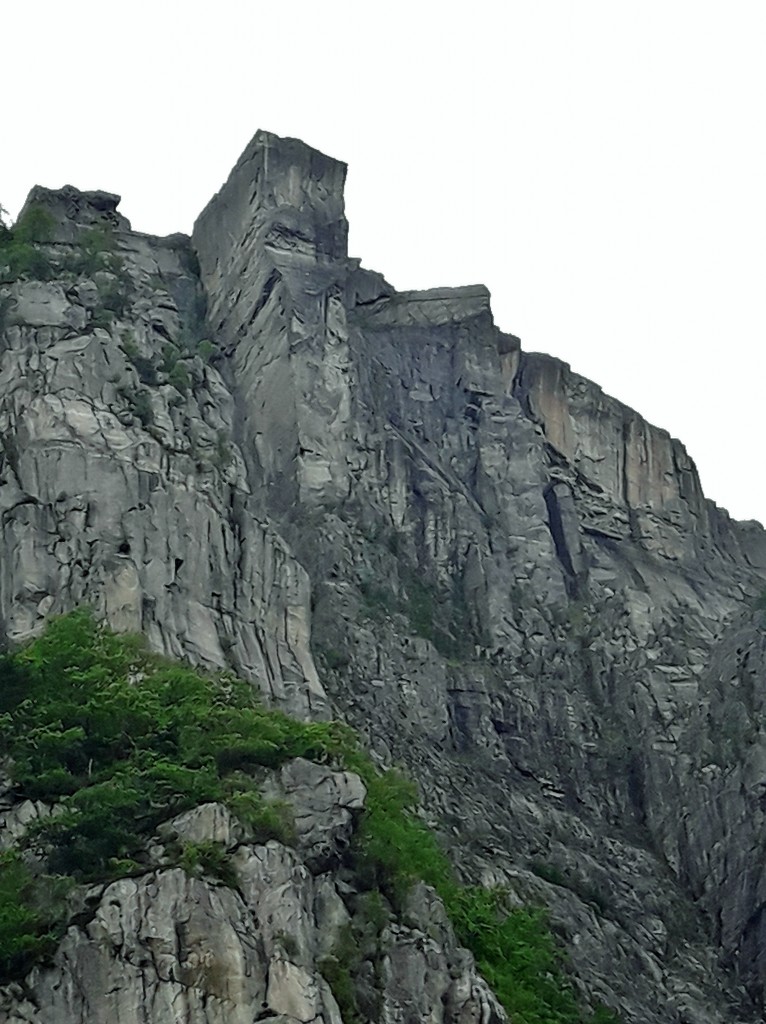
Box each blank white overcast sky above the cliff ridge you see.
[0,0,766,522]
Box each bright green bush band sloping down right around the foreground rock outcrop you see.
[0,610,618,1024]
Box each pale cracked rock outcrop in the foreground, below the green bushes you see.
[0,782,506,1024]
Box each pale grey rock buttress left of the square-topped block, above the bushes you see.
[0,188,324,715]
